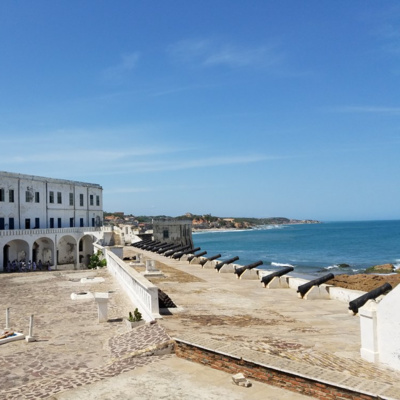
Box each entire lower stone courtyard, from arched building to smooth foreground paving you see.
[0,264,312,400]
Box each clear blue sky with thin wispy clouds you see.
[0,0,400,221]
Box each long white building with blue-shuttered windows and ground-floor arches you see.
[0,172,103,271]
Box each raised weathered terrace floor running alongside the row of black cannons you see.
[126,250,400,399]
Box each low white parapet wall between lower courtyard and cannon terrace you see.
[101,245,160,321]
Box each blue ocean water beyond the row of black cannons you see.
[193,220,400,275]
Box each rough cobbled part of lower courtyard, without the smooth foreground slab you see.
[0,271,172,400]
